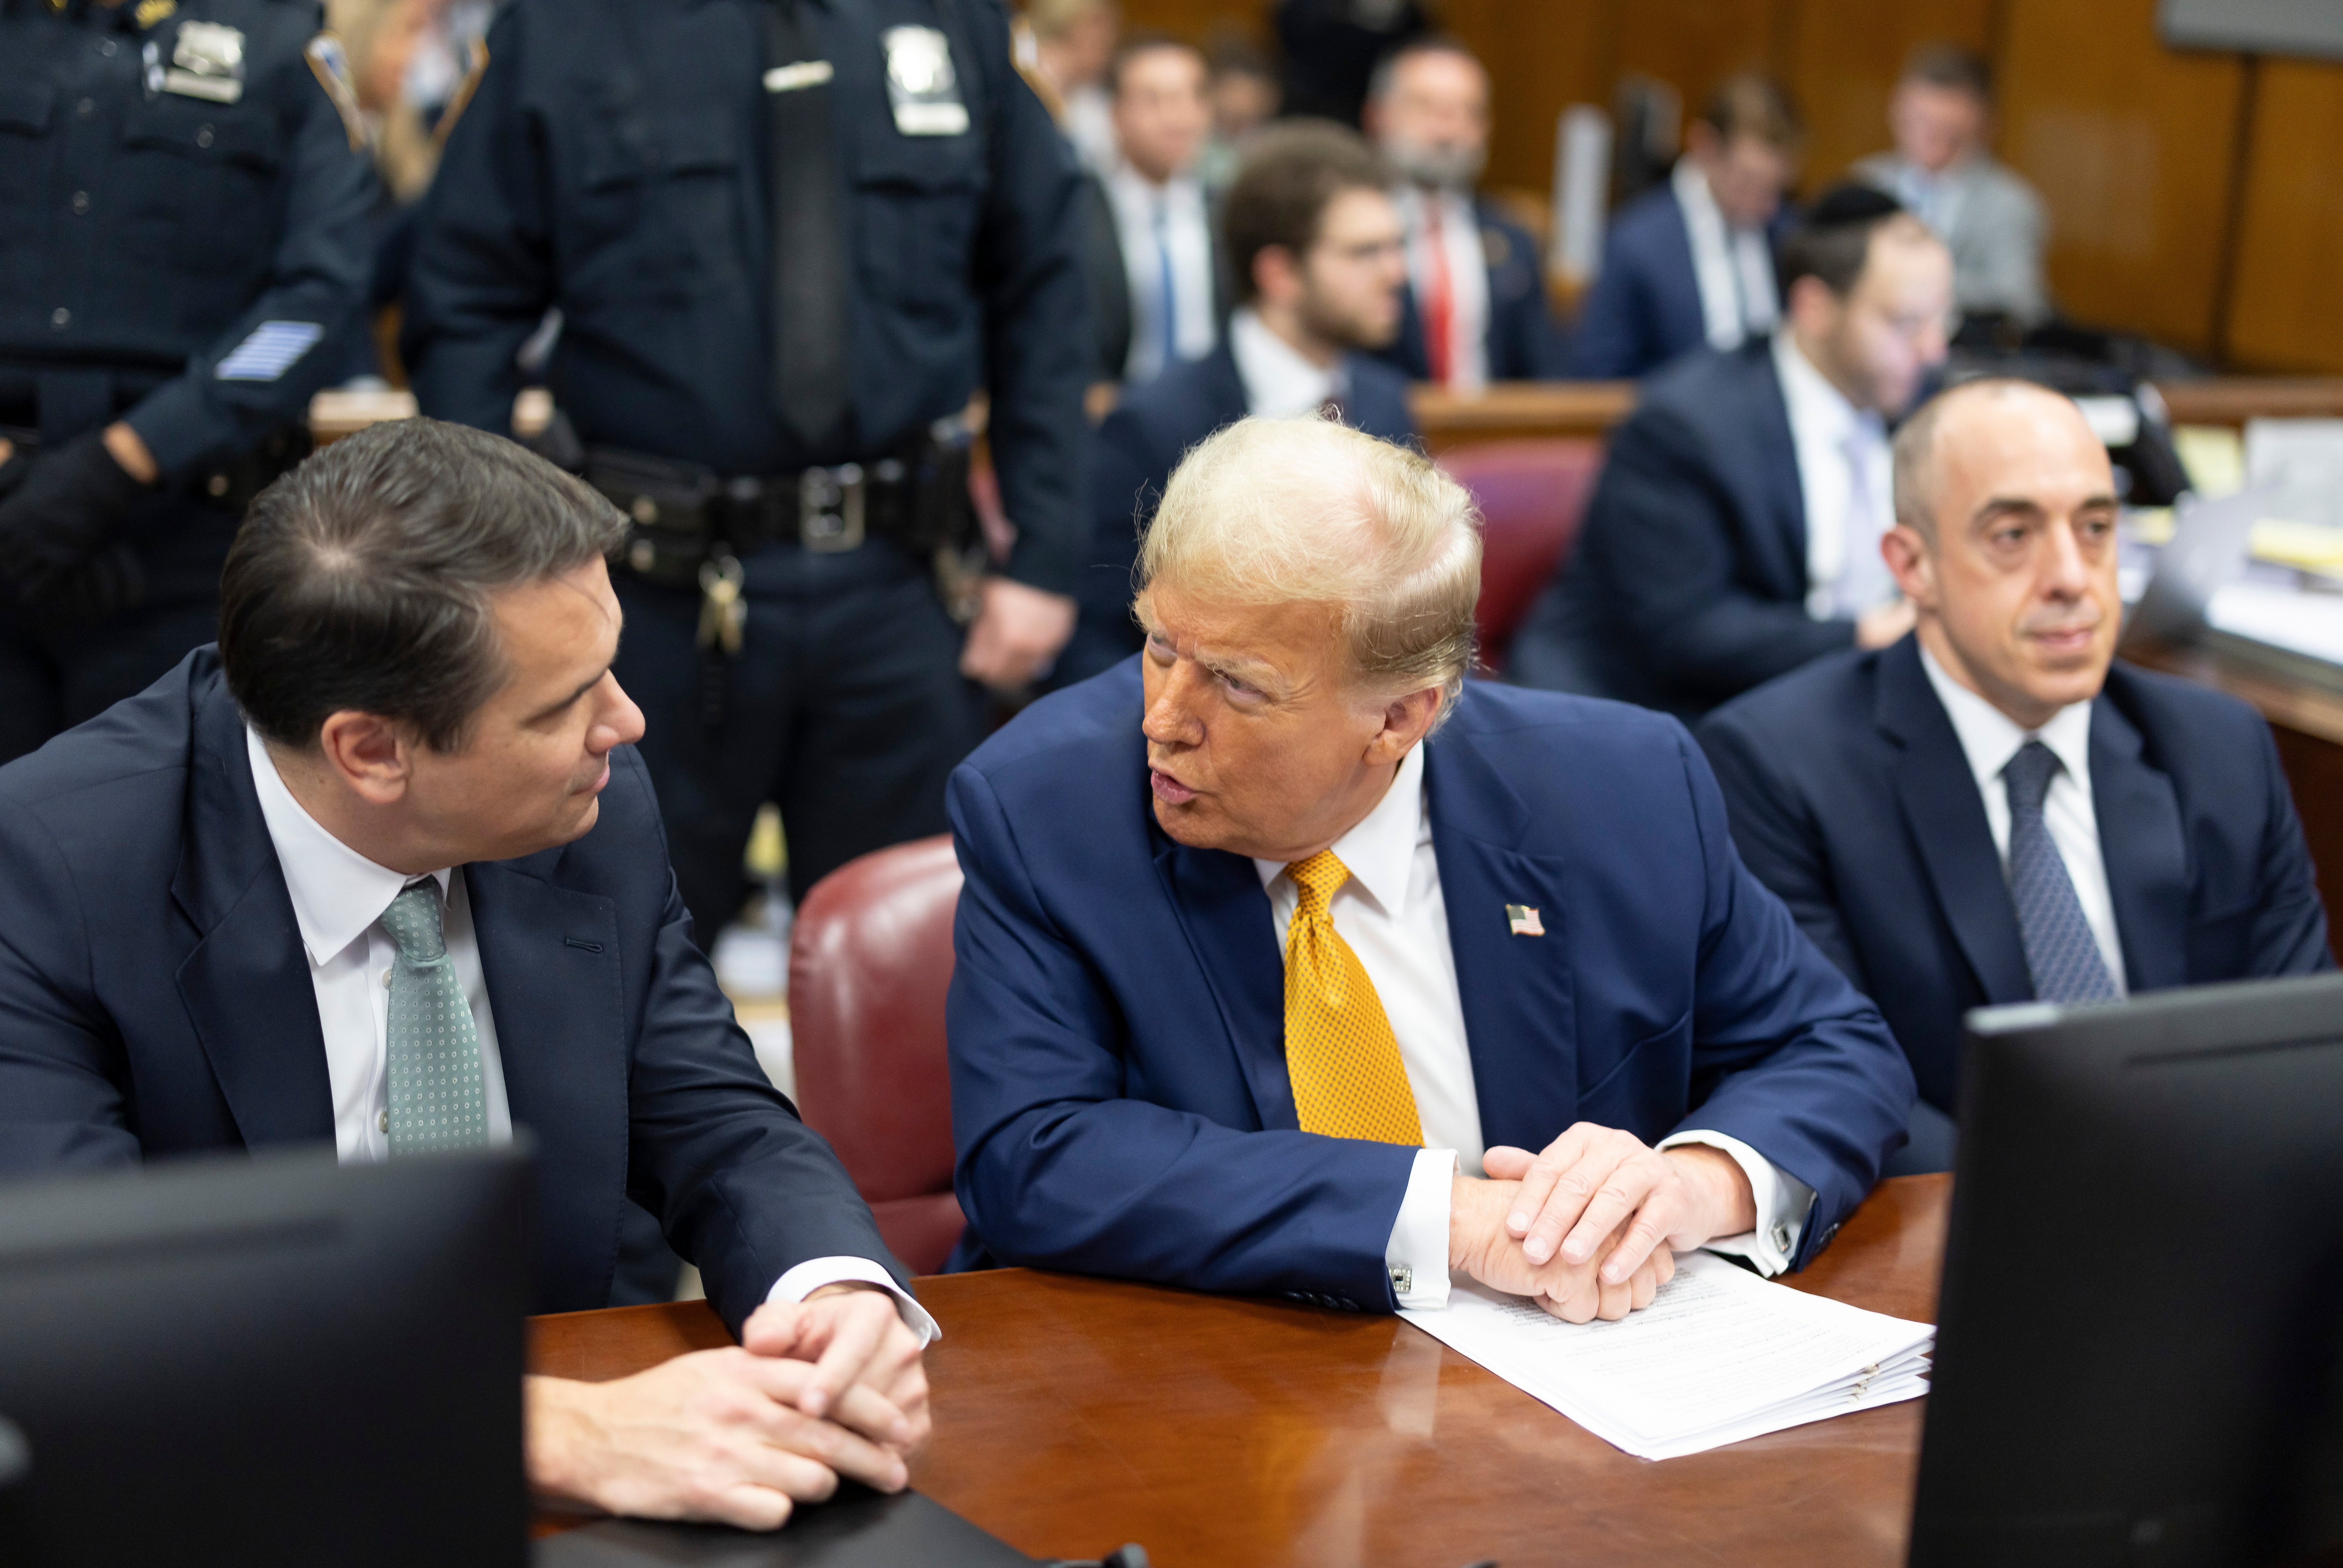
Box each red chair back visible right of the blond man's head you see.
[1441,441,1603,670]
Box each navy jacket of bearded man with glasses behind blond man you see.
[1052,333,1415,687]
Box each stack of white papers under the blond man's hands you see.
[1401,1252,1935,1460]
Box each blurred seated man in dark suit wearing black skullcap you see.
[1507,185,1952,715]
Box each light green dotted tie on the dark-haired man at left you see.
[382,881,487,1158]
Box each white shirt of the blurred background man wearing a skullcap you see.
[1774,333,1895,621]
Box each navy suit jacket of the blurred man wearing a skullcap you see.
[1507,338,1856,715]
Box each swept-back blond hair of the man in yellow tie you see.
[1139,415,1481,717]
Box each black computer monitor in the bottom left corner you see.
[0,1149,529,1568]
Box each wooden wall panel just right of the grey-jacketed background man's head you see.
[2001,0,2242,354]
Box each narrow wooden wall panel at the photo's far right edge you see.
[2228,61,2343,373]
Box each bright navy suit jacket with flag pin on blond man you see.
[947,659,1912,1310]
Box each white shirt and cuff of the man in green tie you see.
[244,726,937,1343]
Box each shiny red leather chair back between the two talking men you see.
[790,837,965,1275]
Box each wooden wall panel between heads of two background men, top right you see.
[1778,0,1994,190]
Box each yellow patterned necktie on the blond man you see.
[1286,848,1424,1144]
